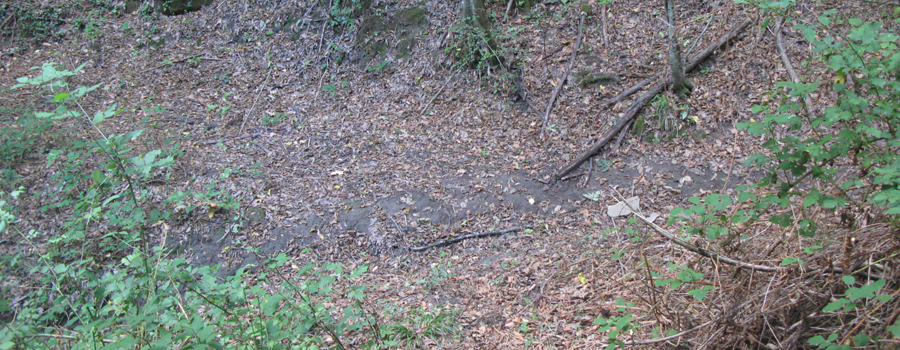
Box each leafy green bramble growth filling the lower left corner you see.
[0,63,416,349]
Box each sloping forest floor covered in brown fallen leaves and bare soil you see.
[0,0,900,349]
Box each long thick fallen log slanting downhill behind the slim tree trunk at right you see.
[554,19,752,181]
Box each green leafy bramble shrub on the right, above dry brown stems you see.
[669,10,900,349]
